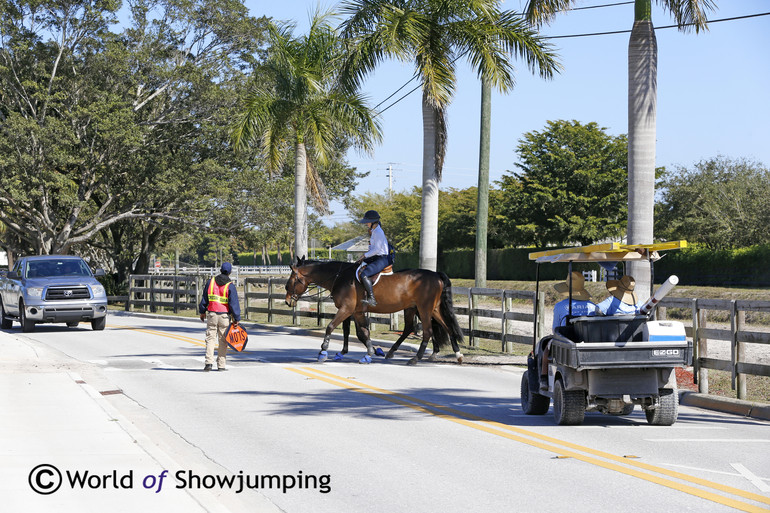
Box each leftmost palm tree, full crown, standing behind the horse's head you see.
[232,13,381,257]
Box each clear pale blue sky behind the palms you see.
[245,0,770,224]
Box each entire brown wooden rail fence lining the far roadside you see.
[126,275,770,399]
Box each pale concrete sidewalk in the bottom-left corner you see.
[0,332,279,513]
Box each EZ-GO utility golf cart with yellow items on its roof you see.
[521,241,692,426]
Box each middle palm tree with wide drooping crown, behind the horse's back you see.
[341,0,559,270]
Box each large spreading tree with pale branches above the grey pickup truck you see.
[0,0,264,273]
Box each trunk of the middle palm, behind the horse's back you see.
[420,93,439,271]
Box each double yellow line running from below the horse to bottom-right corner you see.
[285,367,770,512]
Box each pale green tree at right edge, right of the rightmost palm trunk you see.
[655,156,770,250]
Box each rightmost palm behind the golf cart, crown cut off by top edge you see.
[526,0,715,299]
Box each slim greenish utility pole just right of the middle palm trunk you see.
[475,78,492,288]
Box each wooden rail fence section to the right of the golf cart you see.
[658,297,770,399]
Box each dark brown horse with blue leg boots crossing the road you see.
[286,257,463,365]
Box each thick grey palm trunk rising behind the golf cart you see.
[628,4,658,301]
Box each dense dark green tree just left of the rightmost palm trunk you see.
[493,121,628,246]
